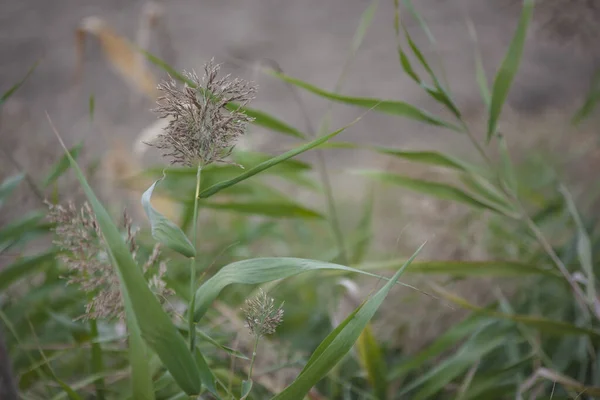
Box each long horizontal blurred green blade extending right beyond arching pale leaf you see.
[356,259,562,279]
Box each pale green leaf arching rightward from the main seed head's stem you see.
[195,253,424,321]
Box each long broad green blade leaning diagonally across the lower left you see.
[48,117,201,395]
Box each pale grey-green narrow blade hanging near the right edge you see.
[560,185,598,305]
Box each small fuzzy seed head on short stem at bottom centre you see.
[243,289,283,337]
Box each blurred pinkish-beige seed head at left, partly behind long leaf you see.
[48,203,171,320]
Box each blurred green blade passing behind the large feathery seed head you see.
[138,48,306,139]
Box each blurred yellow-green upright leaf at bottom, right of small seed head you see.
[356,324,387,400]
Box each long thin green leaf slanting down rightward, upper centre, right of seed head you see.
[271,71,462,132]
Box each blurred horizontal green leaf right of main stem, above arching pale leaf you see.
[200,201,324,219]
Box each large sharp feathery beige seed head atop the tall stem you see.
[152,60,256,167]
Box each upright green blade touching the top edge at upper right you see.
[487,0,535,142]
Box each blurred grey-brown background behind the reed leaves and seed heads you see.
[0,0,600,396]
